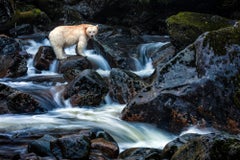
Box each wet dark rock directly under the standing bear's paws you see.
[58,56,92,82]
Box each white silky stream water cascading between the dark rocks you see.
[0,39,212,153]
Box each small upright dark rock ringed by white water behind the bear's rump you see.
[33,46,56,71]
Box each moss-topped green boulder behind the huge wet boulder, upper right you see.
[166,12,233,49]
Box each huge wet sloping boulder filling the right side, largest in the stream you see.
[122,23,240,133]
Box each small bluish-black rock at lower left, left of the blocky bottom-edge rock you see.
[28,135,56,157]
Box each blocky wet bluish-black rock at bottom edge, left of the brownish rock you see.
[51,135,91,160]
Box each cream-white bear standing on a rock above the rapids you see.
[48,24,98,59]
